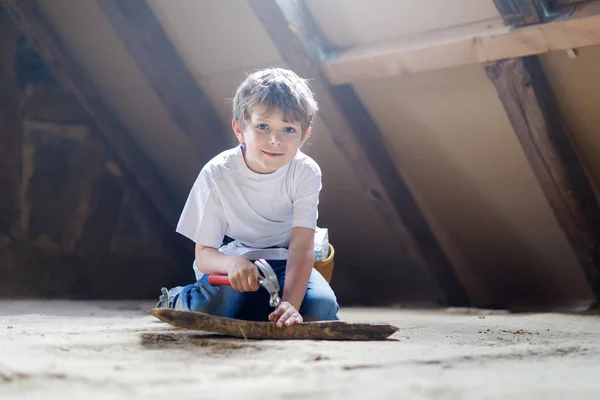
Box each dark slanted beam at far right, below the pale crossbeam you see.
[485,56,600,299]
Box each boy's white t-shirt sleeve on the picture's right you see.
[292,164,322,229]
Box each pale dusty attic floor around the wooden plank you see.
[0,301,600,400]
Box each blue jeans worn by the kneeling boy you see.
[159,260,339,321]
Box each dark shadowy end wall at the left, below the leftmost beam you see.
[0,18,181,298]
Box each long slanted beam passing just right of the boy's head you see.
[249,0,469,305]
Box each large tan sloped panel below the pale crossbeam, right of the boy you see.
[355,66,592,305]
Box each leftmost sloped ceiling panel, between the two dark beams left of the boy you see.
[36,0,208,201]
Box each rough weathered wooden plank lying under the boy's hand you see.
[148,308,398,341]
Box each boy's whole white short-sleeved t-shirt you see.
[177,146,322,279]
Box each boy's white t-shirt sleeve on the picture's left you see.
[176,169,227,249]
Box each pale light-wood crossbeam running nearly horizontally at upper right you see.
[321,0,600,85]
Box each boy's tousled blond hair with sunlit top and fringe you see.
[233,68,318,135]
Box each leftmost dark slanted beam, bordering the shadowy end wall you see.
[5,0,193,266]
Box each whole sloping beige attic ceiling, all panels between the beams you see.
[8,0,600,305]
